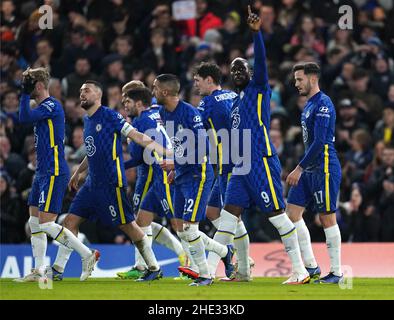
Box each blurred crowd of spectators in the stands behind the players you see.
[0,0,394,243]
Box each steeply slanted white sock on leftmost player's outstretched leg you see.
[40,221,92,259]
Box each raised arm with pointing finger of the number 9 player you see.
[247,6,268,85]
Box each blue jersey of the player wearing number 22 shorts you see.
[160,101,212,183]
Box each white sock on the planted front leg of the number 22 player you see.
[179,224,210,278]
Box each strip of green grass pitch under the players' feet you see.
[0,278,394,300]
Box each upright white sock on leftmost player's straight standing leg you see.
[29,216,48,270]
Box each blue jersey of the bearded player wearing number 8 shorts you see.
[84,106,127,187]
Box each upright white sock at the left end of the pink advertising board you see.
[234,221,250,275]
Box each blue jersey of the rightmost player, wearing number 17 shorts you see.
[300,91,340,172]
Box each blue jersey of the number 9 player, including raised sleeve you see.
[231,31,276,159]
